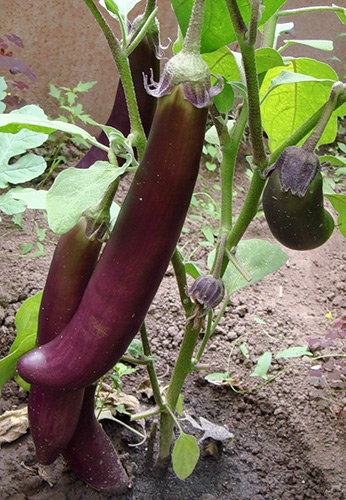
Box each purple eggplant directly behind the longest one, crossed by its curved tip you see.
[28,219,101,464]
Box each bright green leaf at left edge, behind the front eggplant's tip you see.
[0,292,42,389]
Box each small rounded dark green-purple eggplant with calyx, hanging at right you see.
[263,146,334,250]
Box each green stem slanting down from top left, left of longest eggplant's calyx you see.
[84,0,146,160]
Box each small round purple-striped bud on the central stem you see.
[188,274,225,313]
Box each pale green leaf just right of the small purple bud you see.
[215,239,288,294]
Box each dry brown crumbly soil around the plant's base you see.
[0,155,346,500]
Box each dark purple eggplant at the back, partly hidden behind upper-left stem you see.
[76,37,160,168]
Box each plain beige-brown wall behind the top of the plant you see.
[0,0,346,129]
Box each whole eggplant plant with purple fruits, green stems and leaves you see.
[0,0,346,492]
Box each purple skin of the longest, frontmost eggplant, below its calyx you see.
[17,86,208,389]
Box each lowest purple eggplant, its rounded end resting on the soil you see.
[63,386,129,494]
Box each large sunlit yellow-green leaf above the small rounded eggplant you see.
[261,58,346,150]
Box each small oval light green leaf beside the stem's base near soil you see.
[172,432,199,479]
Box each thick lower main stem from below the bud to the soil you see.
[155,312,202,473]
